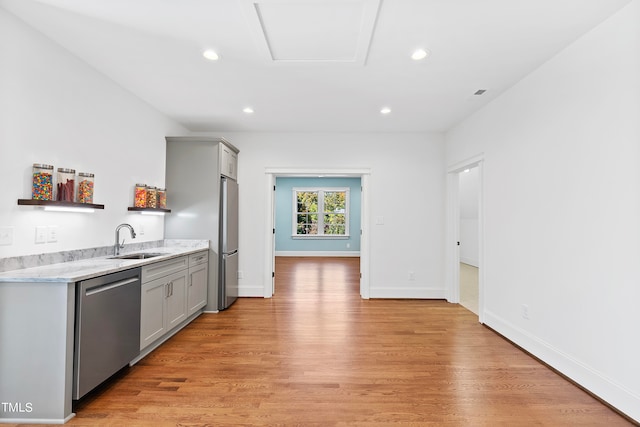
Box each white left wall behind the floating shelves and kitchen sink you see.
[0,9,186,257]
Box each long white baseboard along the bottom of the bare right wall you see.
[484,310,640,422]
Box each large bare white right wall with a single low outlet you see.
[446,0,640,421]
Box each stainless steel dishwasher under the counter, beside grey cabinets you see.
[73,268,141,400]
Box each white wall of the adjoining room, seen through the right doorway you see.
[458,167,480,267]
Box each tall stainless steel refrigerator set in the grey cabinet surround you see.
[218,176,238,310]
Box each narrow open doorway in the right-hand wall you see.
[447,155,484,323]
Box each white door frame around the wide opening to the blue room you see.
[263,168,371,299]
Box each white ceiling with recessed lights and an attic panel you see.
[0,0,630,132]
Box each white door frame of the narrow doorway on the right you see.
[446,153,485,323]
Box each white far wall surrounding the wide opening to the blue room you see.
[202,133,446,298]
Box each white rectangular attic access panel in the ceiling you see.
[244,0,380,65]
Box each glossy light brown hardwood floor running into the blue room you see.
[23,258,631,427]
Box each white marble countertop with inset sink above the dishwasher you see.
[0,240,209,285]
